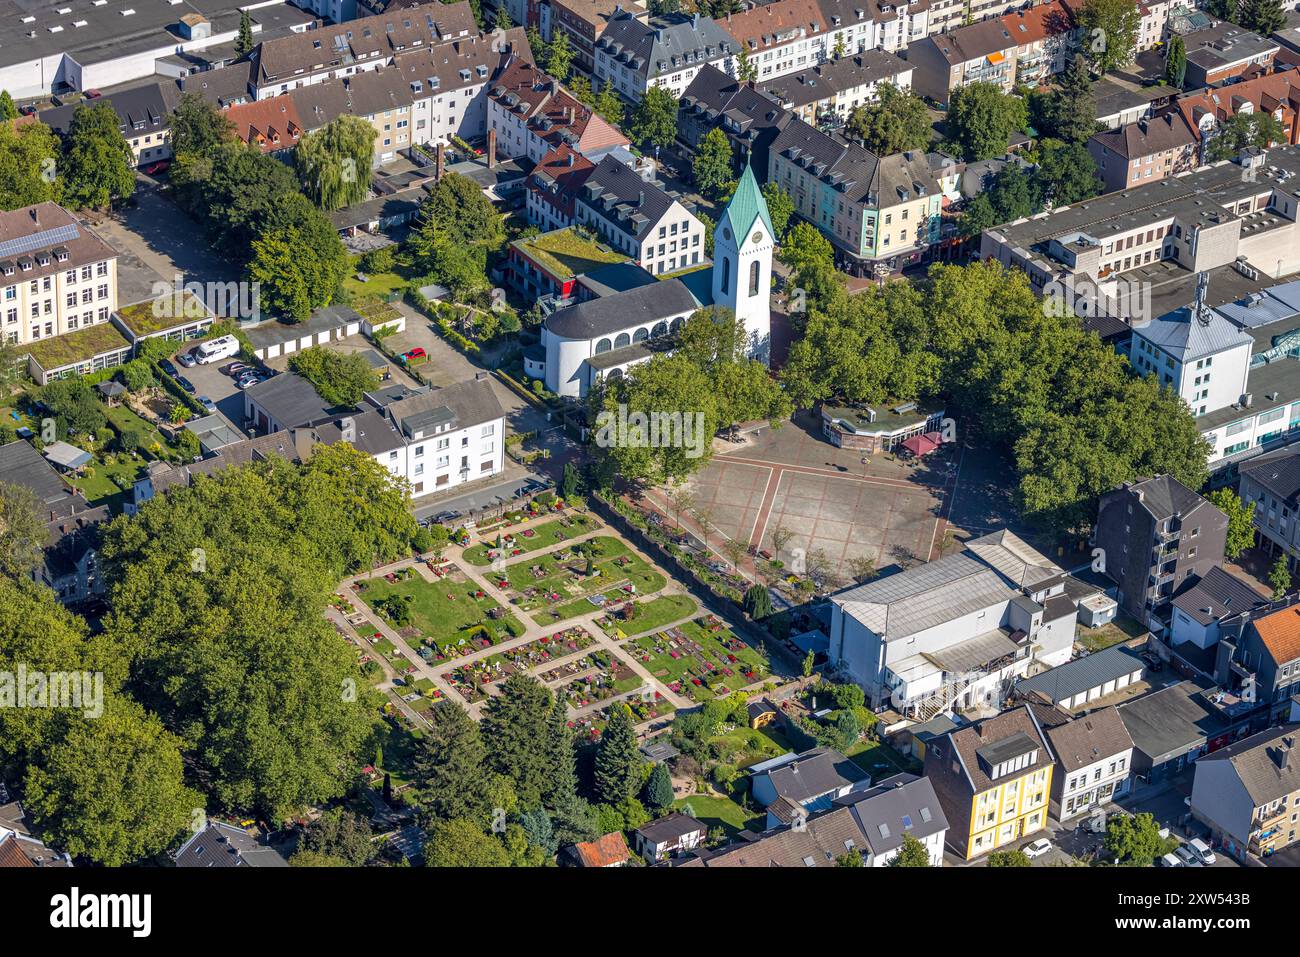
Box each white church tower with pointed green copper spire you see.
[714,165,776,365]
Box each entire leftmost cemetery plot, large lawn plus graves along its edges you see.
[352,564,524,661]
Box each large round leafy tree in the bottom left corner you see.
[23,694,203,867]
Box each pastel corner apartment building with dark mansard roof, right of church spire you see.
[767,118,943,276]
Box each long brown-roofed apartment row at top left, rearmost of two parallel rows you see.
[248,0,478,100]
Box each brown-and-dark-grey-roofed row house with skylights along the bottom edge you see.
[684,774,948,867]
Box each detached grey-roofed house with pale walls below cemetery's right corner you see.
[749,748,871,828]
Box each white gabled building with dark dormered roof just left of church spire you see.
[575,156,707,276]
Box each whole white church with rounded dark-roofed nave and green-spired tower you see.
[524,166,775,399]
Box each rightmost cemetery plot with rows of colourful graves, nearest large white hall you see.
[624,615,771,701]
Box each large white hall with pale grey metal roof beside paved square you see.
[829,531,1075,720]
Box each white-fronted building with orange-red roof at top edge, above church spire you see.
[719,0,831,83]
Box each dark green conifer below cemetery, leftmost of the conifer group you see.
[411,701,490,826]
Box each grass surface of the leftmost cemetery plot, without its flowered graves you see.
[358,572,524,649]
